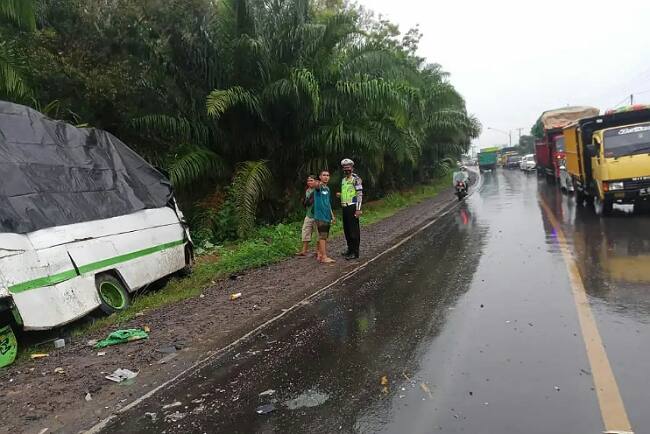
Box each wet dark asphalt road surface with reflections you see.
[104,171,650,434]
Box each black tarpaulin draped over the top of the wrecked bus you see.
[0,101,172,233]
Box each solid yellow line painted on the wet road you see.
[540,198,633,434]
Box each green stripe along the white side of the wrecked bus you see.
[9,240,185,294]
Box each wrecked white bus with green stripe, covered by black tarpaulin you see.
[0,101,192,362]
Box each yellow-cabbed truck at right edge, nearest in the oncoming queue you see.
[564,106,650,215]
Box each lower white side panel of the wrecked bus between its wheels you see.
[12,276,100,330]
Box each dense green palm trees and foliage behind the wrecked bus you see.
[0,0,480,244]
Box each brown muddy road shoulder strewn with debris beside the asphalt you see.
[0,177,466,433]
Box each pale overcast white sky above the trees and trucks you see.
[359,0,650,148]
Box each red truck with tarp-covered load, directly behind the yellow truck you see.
[535,106,600,181]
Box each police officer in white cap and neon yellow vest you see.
[337,158,363,260]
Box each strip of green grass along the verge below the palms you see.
[67,175,451,336]
